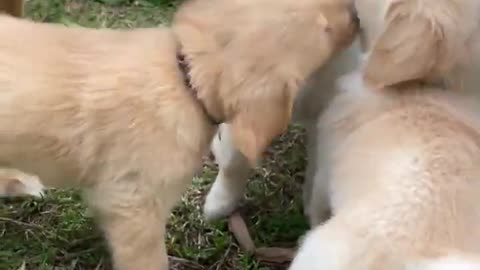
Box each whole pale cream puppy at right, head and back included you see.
[291,0,480,270]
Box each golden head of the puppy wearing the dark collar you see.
[174,0,357,163]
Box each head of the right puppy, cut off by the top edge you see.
[356,0,480,87]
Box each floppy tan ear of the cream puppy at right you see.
[364,1,444,88]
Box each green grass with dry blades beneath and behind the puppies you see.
[0,0,307,270]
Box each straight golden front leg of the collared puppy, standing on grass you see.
[86,173,171,270]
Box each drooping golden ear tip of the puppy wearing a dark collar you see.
[231,87,293,166]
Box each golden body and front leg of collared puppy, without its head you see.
[0,17,214,270]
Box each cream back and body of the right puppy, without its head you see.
[290,64,480,270]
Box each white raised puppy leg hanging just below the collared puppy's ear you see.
[204,124,251,219]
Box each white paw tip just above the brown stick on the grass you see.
[203,181,243,220]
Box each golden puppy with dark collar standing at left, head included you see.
[0,0,357,270]
